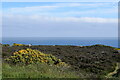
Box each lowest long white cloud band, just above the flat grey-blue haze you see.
[4,15,118,23]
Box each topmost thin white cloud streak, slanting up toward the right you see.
[4,3,117,12]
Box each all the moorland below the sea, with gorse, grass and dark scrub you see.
[2,44,120,80]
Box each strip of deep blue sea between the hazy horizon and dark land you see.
[2,37,118,48]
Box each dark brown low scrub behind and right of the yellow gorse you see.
[2,45,120,78]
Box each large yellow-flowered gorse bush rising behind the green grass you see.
[5,48,67,66]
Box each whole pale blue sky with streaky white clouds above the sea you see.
[2,2,118,37]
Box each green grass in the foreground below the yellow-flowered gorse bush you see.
[2,63,79,78]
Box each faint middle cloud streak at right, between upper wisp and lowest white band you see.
[54,8,118,16]
